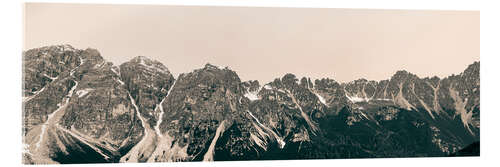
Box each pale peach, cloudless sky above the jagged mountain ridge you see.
[25,3,479,82]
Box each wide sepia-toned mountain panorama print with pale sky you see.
[19,3,480,164]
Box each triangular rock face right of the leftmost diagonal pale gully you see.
[60,49,143,153]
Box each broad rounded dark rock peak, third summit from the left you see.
[160,64,245,160]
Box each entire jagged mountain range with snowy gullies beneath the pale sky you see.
[23,45,480,164]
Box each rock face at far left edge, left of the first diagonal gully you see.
[23,45,83,133]
